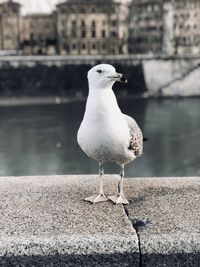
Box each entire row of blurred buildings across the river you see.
[0,0,200,55]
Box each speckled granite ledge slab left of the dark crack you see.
[0,176,139,266]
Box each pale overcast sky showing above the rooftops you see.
[0,0,130,14]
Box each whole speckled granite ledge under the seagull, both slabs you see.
[0,175,200,267]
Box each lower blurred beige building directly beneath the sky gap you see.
[21,13,57,55]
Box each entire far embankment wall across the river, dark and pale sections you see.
[0,55,200,97]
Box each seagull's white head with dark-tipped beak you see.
[88,64,127,89]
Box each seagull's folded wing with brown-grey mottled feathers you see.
[123,114,143,157]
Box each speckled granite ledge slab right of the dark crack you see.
[125,177,200,267]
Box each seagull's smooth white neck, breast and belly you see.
[78,89,135,164]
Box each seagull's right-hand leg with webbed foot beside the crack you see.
[108,164,129,204]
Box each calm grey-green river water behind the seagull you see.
[0,98,200,177]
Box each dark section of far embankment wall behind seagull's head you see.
[0,62,146,97]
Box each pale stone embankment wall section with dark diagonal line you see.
[143,58,200,97]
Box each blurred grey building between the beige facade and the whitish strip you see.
[129,0,163,54]
